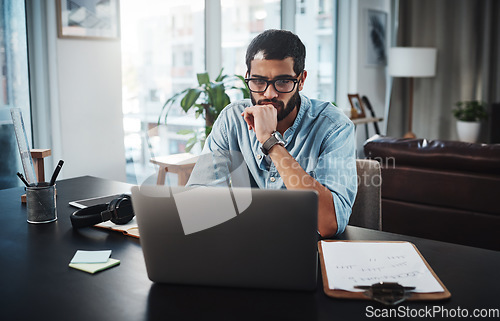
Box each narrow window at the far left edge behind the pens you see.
[0,0,32,188]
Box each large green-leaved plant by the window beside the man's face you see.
[158,69,250,152]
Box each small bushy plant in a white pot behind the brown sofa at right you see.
[453,100,488,143]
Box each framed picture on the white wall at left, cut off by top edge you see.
[56,0,120,40]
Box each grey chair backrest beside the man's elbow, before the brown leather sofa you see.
[349,159,382,230]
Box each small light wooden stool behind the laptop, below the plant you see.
[149,153,198,186]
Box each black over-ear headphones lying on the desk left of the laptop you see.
[70,194,134,228]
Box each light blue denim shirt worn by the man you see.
[188,94,357,234]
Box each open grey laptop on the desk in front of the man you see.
[132,182,318,290]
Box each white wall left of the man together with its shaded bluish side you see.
[27,0,126,181]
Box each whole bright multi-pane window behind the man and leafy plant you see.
[121,0,337,183]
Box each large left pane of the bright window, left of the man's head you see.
[120,0,205,183]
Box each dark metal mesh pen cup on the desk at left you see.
[26,183,57,224]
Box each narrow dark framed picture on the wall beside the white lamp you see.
[365,9,387,66]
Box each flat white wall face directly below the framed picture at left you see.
[57,39,125,181]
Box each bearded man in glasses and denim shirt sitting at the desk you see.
[188,30,357,237]
